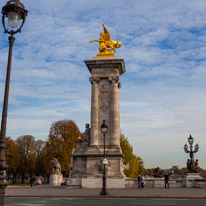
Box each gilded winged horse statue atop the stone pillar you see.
[89,23,122,58]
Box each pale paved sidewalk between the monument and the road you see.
[5,186,206,198]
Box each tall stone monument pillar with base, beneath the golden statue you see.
[69,59,126,188]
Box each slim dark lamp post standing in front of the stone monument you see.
[100,120,109,195]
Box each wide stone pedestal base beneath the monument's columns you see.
[67,150,125,188]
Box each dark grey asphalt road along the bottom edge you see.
[4,197,206,206]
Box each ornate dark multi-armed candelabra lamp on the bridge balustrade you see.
[184,135,199,173]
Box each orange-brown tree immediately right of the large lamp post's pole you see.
[6,137,19,182]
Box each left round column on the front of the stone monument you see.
[89,77,99,147]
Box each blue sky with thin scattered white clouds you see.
[0,0,206,168]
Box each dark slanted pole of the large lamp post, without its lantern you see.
[0,35,15,206]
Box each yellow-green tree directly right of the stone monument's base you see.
[120,134,144,178]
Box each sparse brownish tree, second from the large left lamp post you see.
[16,135,36,183]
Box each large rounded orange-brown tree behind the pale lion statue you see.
[45,120,80,176]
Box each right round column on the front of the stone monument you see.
[109,76,120,148]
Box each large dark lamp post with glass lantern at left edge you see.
[0,0,28,206]
